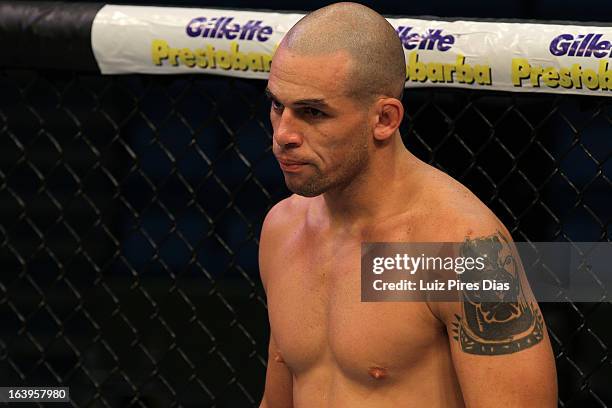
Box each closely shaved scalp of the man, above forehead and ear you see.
[279,3,406,99]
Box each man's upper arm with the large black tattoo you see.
[436,229,557,407]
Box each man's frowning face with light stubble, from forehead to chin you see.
[267,47,371,197]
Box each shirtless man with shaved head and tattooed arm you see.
[260,3,557,408]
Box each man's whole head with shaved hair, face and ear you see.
[266,3,406,197]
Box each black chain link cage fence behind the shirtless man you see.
[0,70,612,407]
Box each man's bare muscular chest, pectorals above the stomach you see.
[268,234,440,380]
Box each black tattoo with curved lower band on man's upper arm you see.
[453,232,544,355]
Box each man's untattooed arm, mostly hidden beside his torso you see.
[259,200,293,408]
